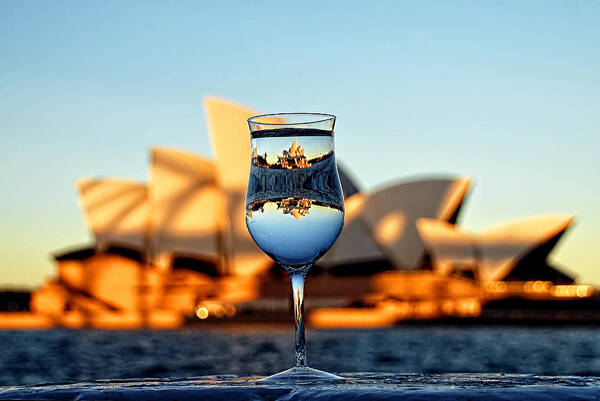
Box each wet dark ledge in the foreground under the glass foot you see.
[0,373,600,401]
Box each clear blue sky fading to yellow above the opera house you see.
[0,1,600,287]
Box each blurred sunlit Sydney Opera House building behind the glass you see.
[0,98,593,328]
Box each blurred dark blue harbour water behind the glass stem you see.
[0,325,600,386]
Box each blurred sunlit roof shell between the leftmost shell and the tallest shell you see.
[149,147,227,267]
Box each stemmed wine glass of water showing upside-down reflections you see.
[246,113,344,383]
